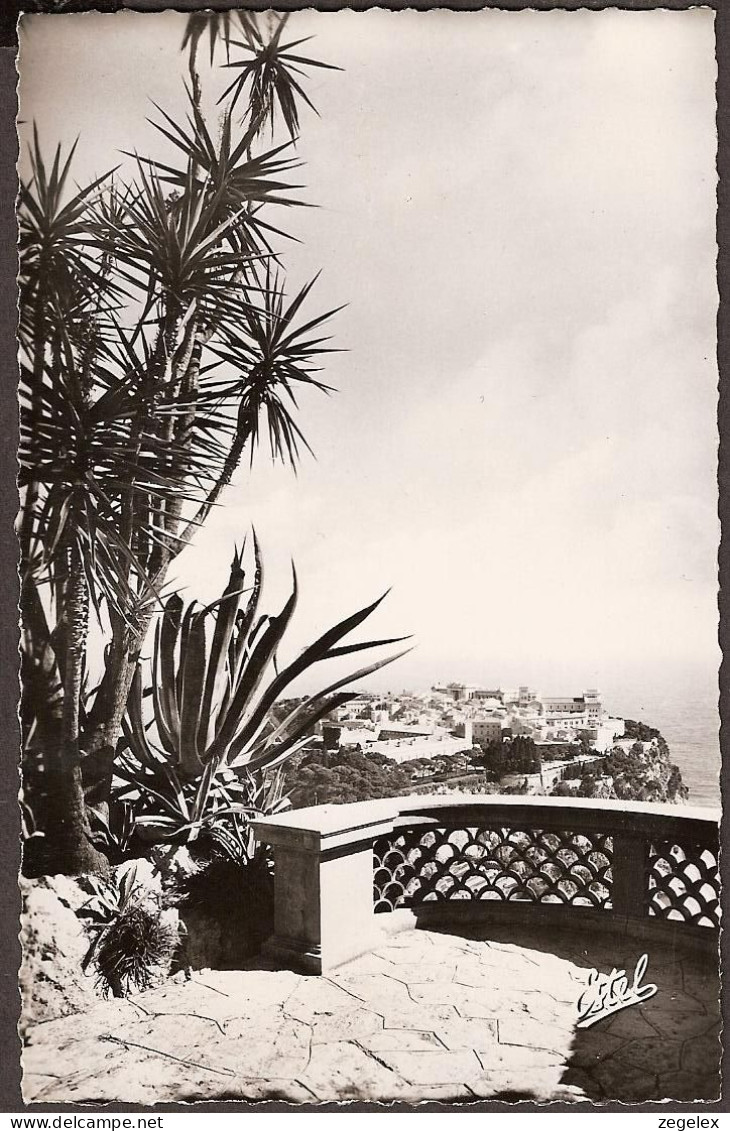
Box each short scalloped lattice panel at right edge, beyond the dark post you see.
[649,840,720,926]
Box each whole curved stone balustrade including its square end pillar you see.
[255,794,720,973]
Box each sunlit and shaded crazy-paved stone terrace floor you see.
[24,926,720,1105]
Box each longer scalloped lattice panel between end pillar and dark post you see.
[373,826,613,912]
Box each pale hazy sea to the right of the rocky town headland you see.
[601,668,720,808]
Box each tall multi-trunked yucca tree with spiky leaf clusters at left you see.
[19,14,359,871]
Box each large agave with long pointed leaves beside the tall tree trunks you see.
[118,538,405,856]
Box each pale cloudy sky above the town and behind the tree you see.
[19,9,719,693]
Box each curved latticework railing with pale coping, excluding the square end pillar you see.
[373,797,720,926]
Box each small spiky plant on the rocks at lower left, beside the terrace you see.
[78,864,180,998]
